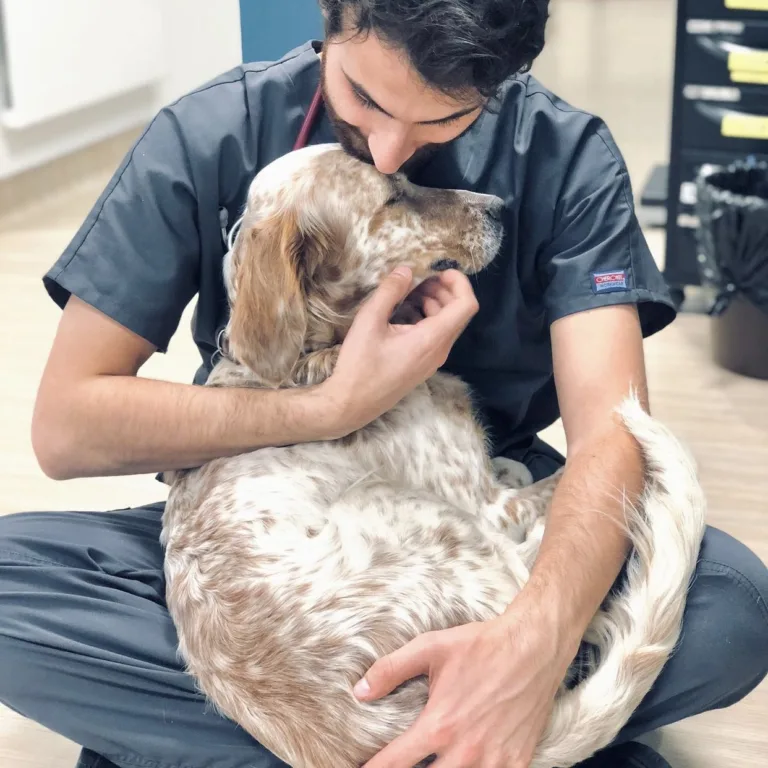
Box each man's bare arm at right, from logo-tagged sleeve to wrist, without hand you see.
[526,305,648,647]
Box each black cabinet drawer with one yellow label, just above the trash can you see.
[680,85,768,155]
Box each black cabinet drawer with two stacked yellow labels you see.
[683,19,768,86]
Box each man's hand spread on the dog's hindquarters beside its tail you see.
[355,594,576,768]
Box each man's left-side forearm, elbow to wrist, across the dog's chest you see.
[33,376,336,479]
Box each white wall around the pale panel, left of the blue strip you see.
[0,0,242,179]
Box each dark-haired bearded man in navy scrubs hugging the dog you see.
[0,0,768,768]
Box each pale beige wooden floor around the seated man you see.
[0,0,768,768]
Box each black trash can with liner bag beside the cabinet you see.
[696,160,768,380]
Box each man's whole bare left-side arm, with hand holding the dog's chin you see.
[32,270,477,479]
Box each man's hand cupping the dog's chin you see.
[321,267,478,433]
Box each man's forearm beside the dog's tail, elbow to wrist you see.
[512,425,643,645]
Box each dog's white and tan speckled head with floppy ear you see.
[224,145,502,386]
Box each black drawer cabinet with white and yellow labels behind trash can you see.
[664,0,768,288]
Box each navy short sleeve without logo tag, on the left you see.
[43,109,200,352]
